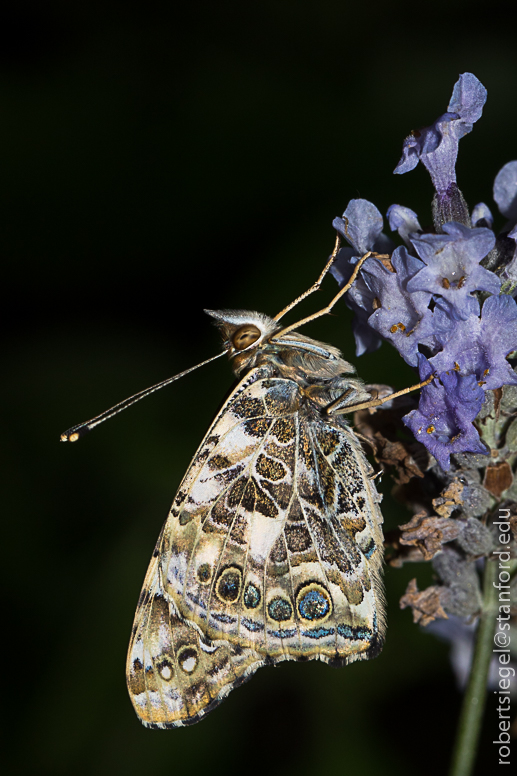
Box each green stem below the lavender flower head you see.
[450,560,498,776]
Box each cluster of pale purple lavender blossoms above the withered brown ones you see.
[331,73,517,470]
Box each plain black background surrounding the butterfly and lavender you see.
[5,0,517,776]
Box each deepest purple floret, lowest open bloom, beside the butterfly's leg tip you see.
[403,355,487,471]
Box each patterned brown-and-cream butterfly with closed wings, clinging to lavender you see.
[62,254,394,728]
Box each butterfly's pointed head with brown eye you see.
[205,310,281,373]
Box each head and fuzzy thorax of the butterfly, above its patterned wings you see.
[206,310,369,416]
